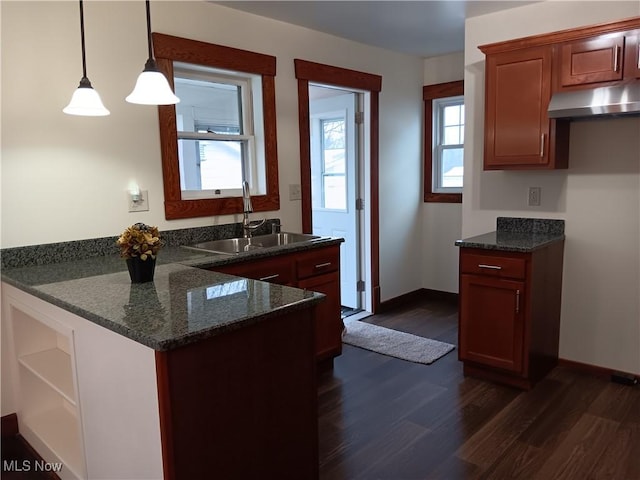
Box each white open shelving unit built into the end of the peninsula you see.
[9,300,86,479]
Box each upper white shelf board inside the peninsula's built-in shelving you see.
[18,348,76,406]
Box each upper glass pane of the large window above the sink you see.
[175,76,243,135]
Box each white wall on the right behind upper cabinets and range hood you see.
[462,1,640,374]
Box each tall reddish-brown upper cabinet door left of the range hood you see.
[484,46,566,170]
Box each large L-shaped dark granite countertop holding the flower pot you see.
[2,238,343,350]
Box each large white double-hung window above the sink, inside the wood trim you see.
[174,63,265,199]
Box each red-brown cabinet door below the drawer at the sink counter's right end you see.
[298,271,342,360]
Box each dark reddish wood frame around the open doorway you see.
[294,58,382,313]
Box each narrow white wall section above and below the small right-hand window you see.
[422,52,464,293]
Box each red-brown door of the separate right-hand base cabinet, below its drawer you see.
[458,275,525,373]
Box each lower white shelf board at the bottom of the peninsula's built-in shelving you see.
[20,406,84,478]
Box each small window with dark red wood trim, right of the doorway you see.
[423,81,464,203]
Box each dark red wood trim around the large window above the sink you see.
[153,33,280,220]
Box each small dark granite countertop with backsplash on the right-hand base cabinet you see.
[456,217,564,252]
